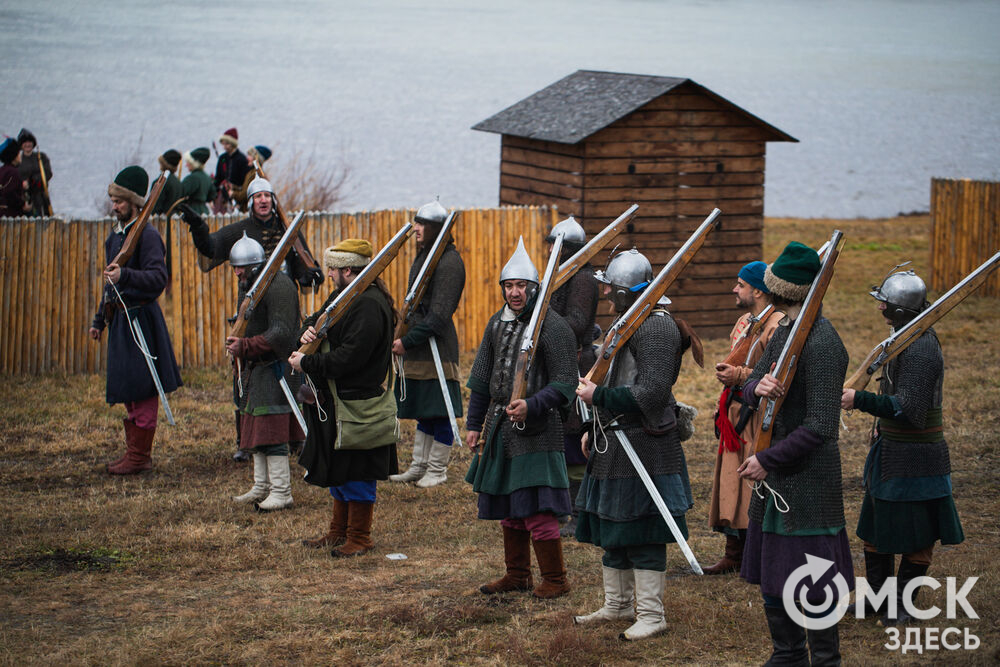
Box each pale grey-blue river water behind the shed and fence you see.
[0,0,1000,217]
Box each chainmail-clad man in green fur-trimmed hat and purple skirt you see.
[738,241,854,665]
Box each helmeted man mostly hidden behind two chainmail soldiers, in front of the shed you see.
[545,216,598,537]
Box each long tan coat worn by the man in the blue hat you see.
[708,309,785,530]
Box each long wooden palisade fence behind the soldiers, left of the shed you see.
[0,207,555,374]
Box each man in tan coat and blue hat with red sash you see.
[705,261,785,574]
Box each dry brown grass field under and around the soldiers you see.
[0,217,1000,665]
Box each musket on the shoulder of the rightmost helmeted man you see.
[844,252,1000,391]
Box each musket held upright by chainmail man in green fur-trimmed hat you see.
[753,229,844,454]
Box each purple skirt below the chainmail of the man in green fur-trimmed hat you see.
[740,520,854,604]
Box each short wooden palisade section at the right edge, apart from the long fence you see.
[930,178,1000,296]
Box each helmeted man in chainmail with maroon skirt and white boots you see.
[226,234,305,512]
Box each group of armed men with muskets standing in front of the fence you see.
[91,167,963,665]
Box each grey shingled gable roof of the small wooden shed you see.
[472,70,798,144]
